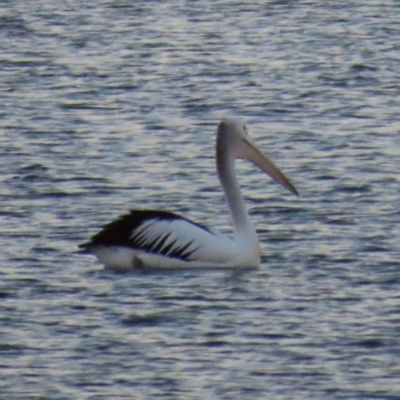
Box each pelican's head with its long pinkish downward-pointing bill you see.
[217,119,299,196]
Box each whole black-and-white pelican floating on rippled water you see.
[79,119,299,270]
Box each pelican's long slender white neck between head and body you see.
[217,146,258,238]
